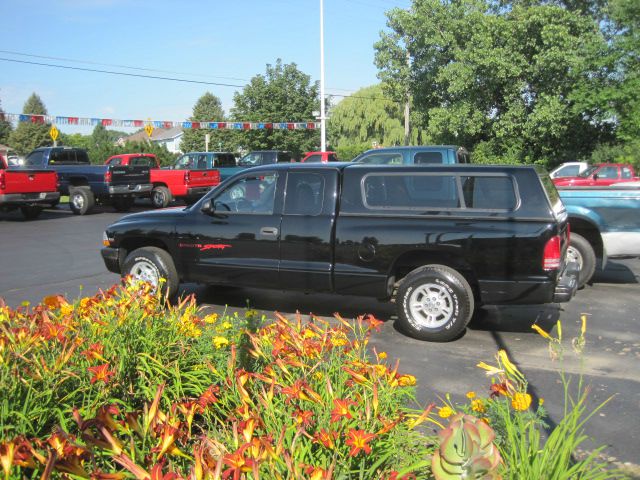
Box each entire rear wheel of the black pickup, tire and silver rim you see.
[396,265,474,342]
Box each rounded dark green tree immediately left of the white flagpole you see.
[231,59,320,157]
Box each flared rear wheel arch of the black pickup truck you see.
[389,251,480,303]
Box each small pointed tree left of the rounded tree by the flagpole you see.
[180,92,234,152]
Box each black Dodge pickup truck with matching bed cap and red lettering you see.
[102,163,577,341]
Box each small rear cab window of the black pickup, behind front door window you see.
[284,172,324,215]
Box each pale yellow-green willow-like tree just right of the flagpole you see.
[327,85,424,159]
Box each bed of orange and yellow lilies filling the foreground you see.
[0,284,624,480]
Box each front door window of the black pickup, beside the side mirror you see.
[213,173,278,215]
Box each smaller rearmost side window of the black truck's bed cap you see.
[461,176,517,210]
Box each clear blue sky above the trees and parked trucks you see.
[0,0,410,133]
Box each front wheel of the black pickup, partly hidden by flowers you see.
[122,247,179,298]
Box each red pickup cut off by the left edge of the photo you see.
[0,155,60,220]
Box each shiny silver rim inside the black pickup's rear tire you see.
[409,283,455,328]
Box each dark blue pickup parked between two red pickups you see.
[25,147,152,215]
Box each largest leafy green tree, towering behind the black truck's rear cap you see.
[375,0,613,166]
